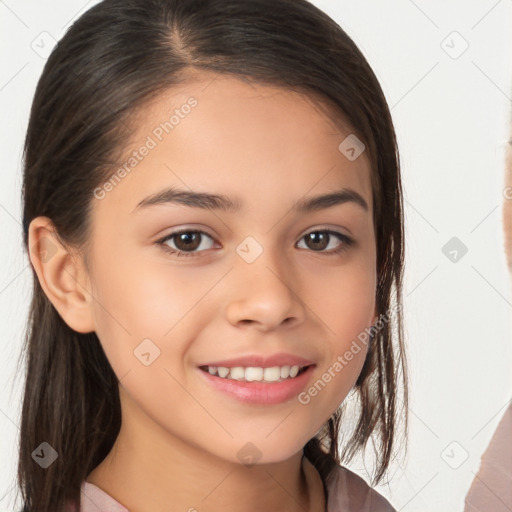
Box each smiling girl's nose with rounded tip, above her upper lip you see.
[225,250,306,331]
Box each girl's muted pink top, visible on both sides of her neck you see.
[80,461,396,512]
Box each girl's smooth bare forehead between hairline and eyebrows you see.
[94,72,371,216]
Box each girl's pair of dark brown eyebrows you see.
[132,187,369,213]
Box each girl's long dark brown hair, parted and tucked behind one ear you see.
[18,0,407,512]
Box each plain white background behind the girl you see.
[0,0,512,512]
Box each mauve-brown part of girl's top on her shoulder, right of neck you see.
[325,466,396,512]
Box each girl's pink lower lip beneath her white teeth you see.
[198,365,315,405]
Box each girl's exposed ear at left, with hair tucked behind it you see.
[28,217,95,333]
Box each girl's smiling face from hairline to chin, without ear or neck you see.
[82,73,376,463]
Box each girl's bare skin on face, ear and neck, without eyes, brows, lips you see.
[29,72,377,512]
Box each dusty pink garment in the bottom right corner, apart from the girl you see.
[464,405,512,512]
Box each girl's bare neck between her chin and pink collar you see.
[87,388,325,512]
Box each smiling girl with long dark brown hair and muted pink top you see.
[18,0,407,512]
